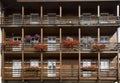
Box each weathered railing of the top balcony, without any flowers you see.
[1,16,120,25]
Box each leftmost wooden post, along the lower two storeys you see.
[1,28,5,79]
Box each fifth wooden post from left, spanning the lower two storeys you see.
[78,28,81,81]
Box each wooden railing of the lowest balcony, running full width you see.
[4,68,117,79]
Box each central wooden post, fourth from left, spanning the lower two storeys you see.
[59,28,62,82]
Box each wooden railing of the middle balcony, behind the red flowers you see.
[2,43,119,52]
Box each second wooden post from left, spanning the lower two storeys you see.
[22,28,24,82]
